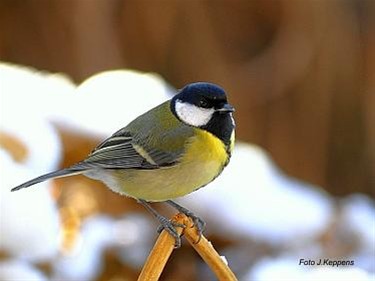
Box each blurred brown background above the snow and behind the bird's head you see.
[0,0,375,196]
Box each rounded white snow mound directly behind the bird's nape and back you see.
[71,70,172,136]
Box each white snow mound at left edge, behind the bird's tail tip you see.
[0,149,59,261]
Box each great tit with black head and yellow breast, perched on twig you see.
[12,82,235,247]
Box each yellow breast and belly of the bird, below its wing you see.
[111,129,228,201]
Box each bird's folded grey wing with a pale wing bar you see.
[75,130,179,169]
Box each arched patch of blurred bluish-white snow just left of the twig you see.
[54,214,156,281]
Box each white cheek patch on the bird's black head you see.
[175,100,215,127]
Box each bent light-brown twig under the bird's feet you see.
[138,214,237,281]
